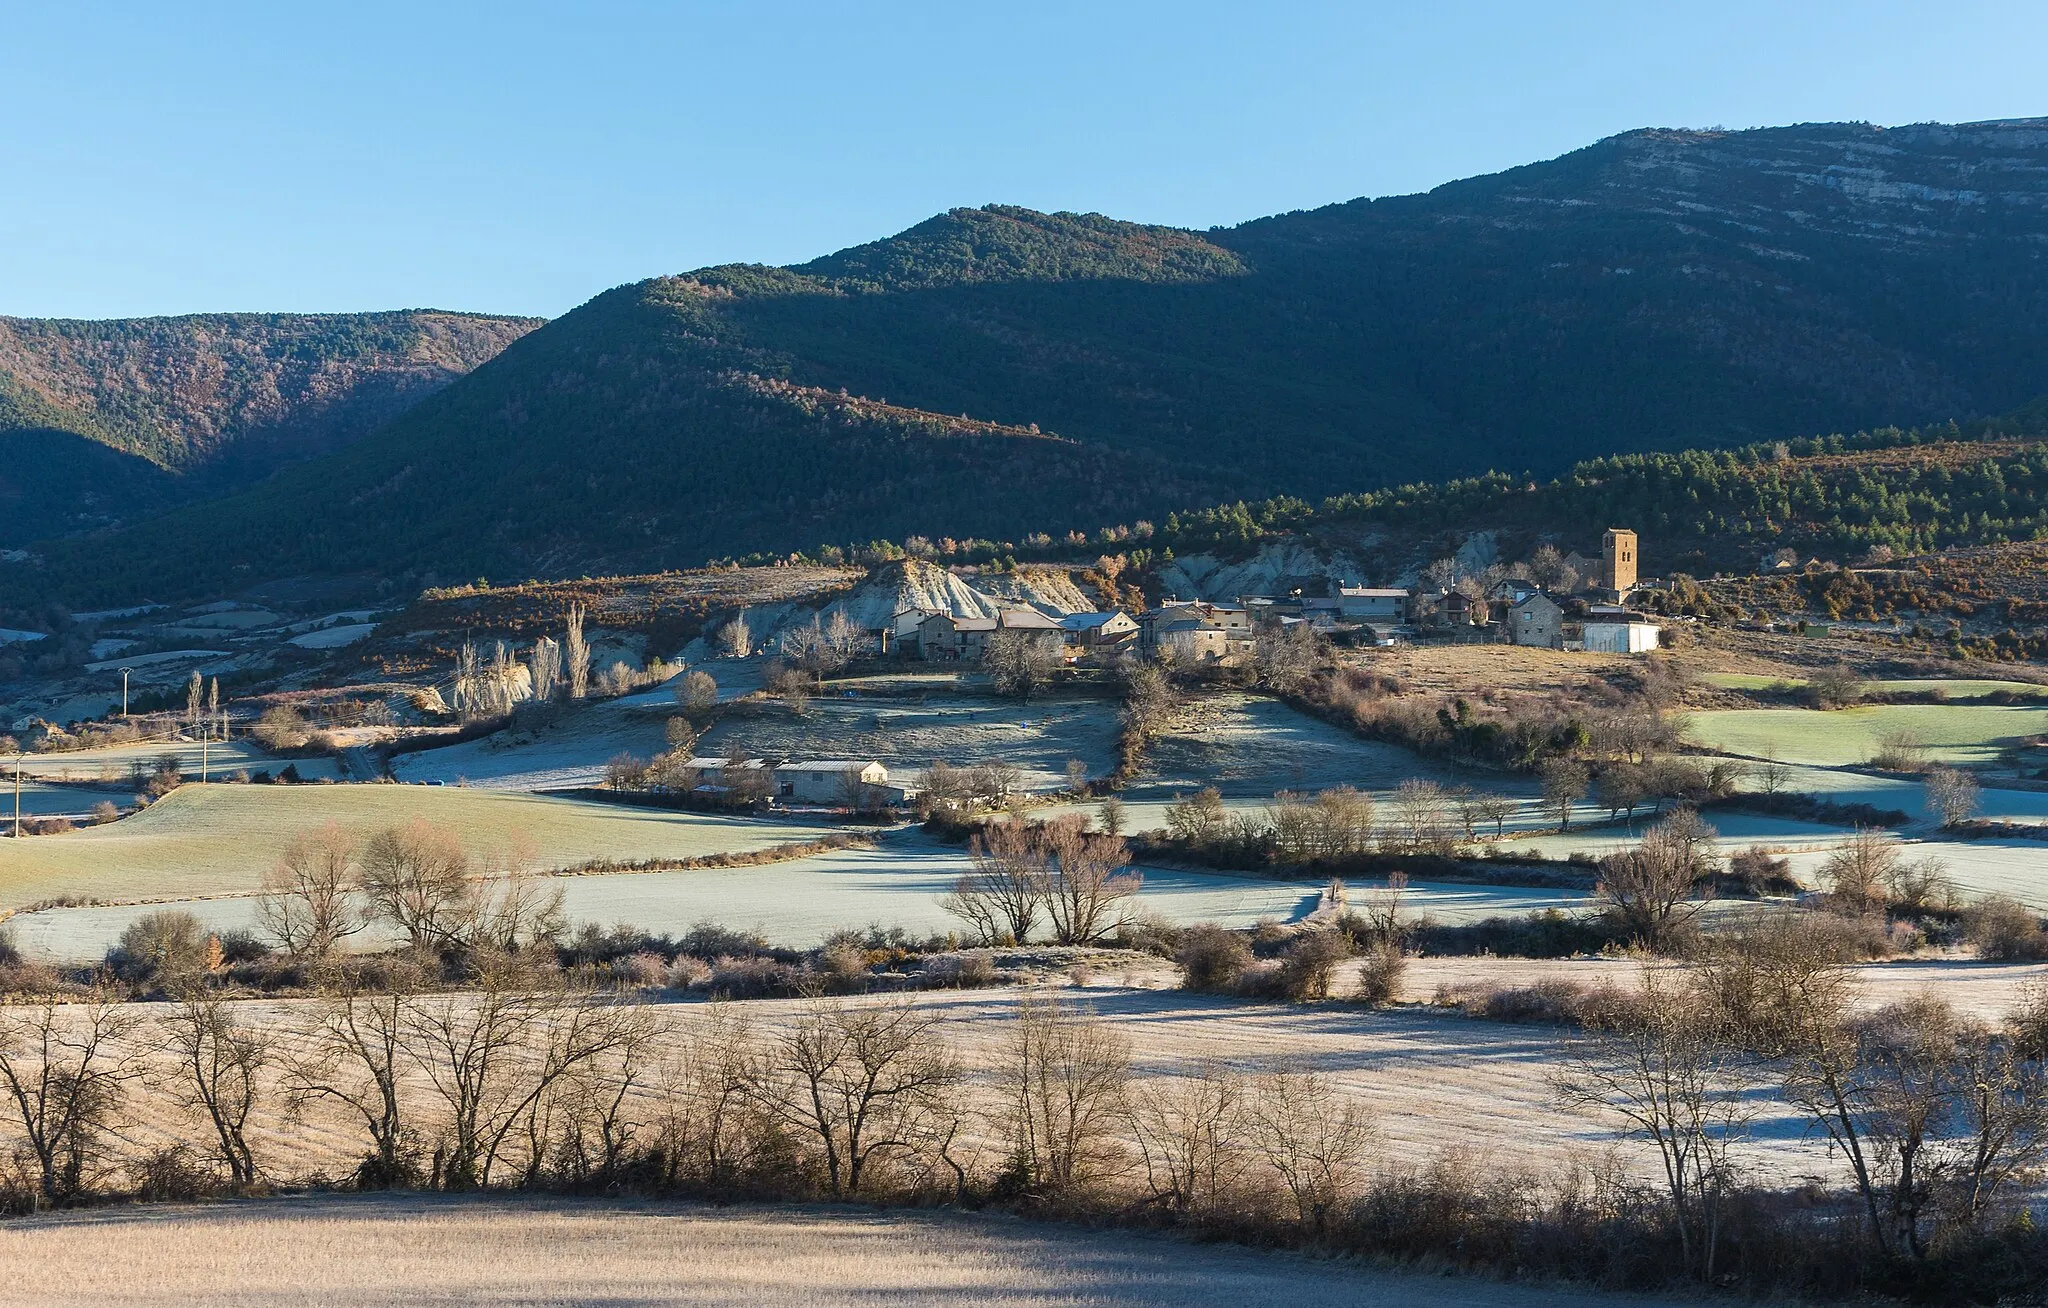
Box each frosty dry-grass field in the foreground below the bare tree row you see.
[0,1197,1695,1308]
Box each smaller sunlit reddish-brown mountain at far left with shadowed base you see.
[0,311,541,544]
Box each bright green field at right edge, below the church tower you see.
[1690,704,2048,768]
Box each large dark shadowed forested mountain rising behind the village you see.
[19,119,2048,594]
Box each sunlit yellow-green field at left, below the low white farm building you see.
[0,786,839,909]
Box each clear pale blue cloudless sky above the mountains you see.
[0,0,2048,317]
